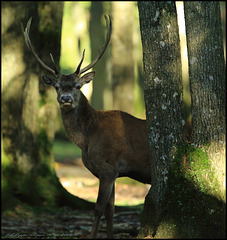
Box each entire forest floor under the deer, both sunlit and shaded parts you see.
[1,159,149,239]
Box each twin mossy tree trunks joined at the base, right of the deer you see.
[138,2,226,238]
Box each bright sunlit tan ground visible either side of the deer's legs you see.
[55,160,150,206]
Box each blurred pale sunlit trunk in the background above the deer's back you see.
[112,2,134,114]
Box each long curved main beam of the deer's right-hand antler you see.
[79,15,112,75]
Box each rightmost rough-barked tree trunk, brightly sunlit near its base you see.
[184,2,226,200]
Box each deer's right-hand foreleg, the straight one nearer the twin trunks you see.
[104,184,115,239]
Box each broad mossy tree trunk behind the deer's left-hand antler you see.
[2,2,92,212]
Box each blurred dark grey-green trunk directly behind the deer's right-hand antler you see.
[89,1,112,110]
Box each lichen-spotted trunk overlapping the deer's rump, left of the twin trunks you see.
[138,1,185,237]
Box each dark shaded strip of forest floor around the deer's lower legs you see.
[1,206,143,239]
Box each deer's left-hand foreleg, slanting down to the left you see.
[90,176,115,238]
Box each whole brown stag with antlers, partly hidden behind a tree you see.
[22,16,151,238]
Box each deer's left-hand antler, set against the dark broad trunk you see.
[21,17,59,76]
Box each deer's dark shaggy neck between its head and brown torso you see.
[61,92,97,150]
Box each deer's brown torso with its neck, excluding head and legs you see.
[61,92,150,183]
